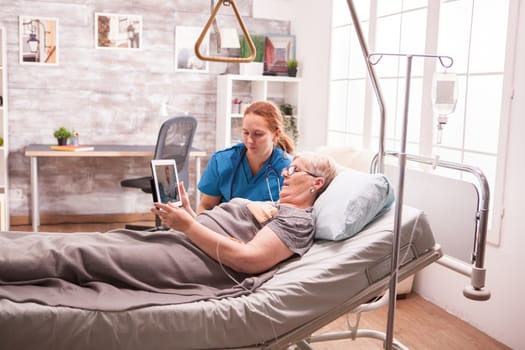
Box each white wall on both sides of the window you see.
[286,0,525,349]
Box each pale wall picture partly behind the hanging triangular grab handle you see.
[175,26,209,72]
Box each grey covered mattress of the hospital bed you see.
[0,206,436,350]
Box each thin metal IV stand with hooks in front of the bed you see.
[368,53,454,350]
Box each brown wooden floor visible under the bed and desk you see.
[7,223,510,350]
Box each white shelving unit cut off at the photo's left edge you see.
[0,27,9,230]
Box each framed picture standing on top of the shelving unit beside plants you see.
[264,34,295,75]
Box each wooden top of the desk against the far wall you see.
[25,144,206,157]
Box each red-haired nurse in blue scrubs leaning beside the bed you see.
[197,101,294,212]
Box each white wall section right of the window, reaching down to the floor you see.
[416,4,525,349]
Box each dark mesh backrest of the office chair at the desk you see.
[154,116,197,184]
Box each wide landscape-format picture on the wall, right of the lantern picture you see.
[95,13,142,50]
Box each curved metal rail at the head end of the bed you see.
[371,151,490,301]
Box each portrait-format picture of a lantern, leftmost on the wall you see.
[18,16,58,65]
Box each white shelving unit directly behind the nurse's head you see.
[216,74,301,149]
